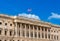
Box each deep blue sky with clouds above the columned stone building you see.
[0,0,60,25]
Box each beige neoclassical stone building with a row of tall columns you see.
[0,14,60,41]
